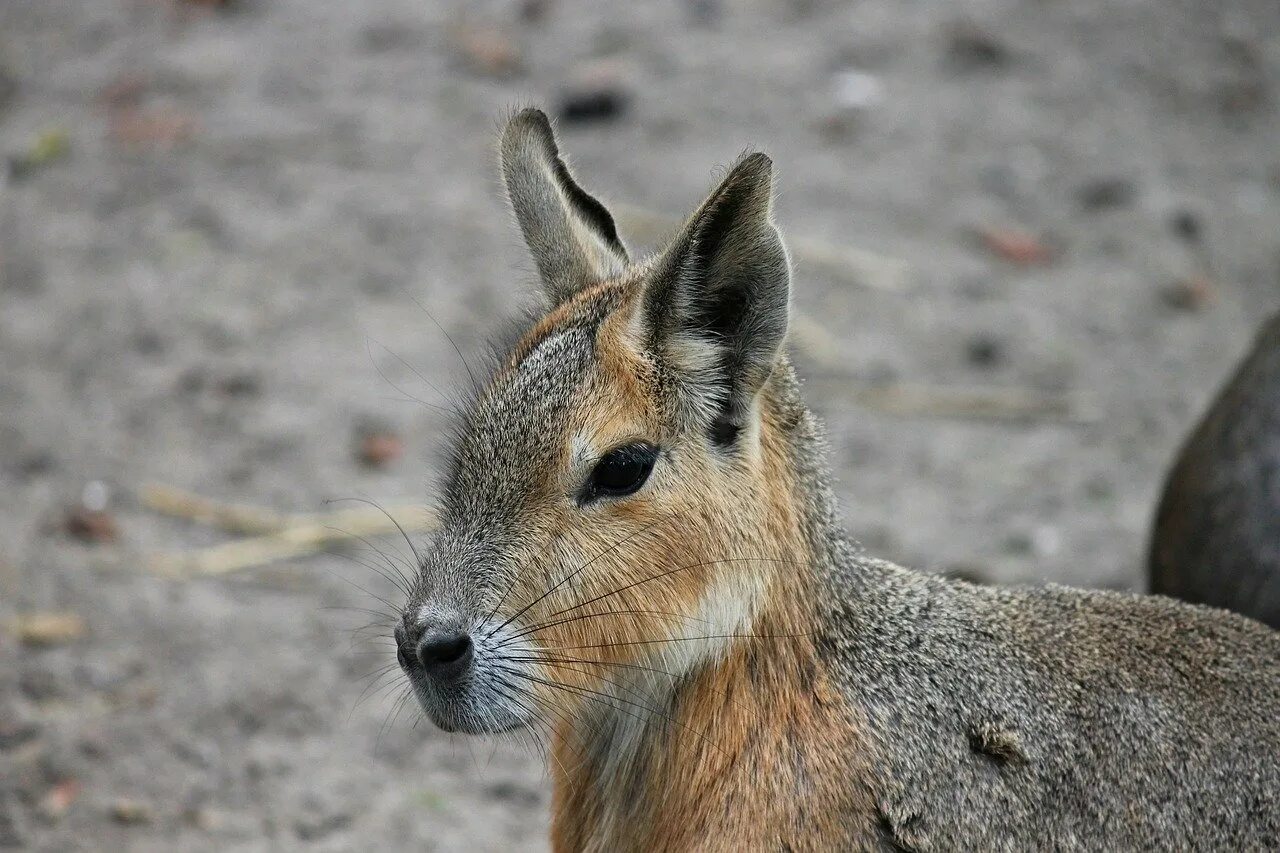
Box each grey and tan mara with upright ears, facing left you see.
[396,110,1280,850]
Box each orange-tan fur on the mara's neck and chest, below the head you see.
[552,386,872,850]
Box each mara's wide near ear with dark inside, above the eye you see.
[639,154,791,444]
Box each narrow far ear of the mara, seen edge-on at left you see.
[502,109,628,305]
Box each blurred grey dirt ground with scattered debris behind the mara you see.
[0,0,1280,850]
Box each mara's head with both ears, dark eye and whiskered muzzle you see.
[396,110,812,733]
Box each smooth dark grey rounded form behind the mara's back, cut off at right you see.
[1148,308,1280,628]
